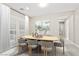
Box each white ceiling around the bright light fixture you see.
[6,3,79,16]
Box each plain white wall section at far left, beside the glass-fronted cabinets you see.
[0,4,10,52]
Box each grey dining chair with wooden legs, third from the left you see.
[38,41,54,56]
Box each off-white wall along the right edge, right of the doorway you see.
[64,9,79,45]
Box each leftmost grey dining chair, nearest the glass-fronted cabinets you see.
[18,38,27,53]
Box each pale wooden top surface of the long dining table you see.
[20,35,59,41]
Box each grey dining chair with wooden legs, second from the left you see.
[27,39,38,56]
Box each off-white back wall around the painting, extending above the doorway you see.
[29,11,73,35]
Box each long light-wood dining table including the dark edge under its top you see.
[18,35,60,55]
